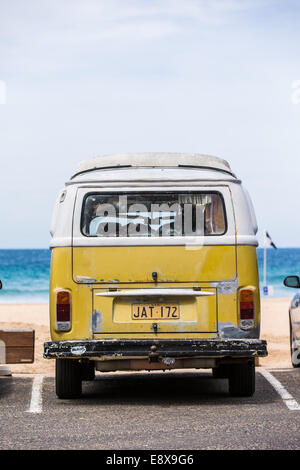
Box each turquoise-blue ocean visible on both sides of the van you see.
[0,248,300,303]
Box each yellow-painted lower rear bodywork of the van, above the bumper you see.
[50,242,260,341]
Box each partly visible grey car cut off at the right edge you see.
[283,276,300,367]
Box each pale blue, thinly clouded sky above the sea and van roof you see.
[0,0,300,248]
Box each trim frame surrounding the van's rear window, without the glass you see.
[80,188,228,239]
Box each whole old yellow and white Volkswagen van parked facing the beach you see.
[44,153,267,398]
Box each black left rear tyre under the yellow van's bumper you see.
[55,359,81,398]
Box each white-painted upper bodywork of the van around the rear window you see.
[50,159,258,250]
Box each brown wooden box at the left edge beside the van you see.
[0,329,35,364]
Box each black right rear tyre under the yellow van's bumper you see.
[229,360,255,397]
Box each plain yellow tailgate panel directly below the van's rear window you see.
[73,246,236,284]
